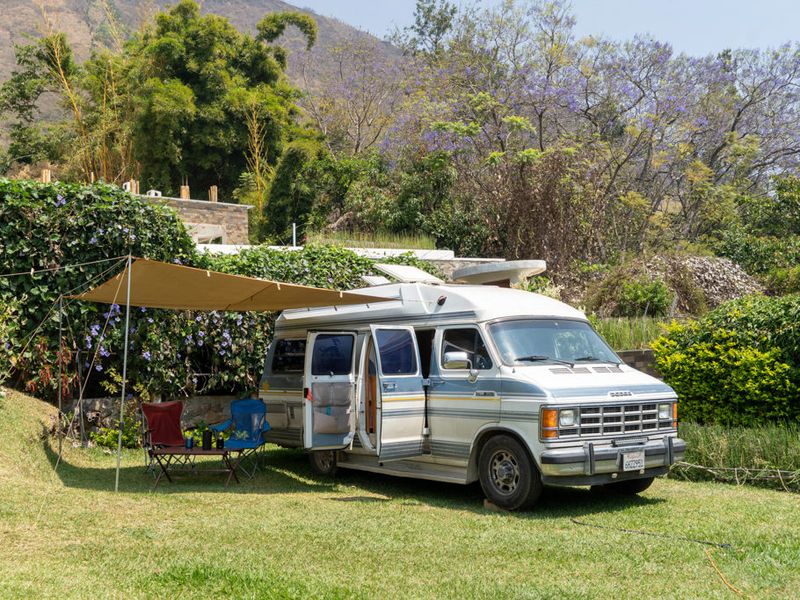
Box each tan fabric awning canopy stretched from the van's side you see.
[71,258,388,311]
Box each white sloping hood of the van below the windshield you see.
[514,363,676,400]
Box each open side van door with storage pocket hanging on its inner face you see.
[303,331,356,450]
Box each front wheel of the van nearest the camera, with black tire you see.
[478,435,542,510]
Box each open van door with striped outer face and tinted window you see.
[371,325,425,461]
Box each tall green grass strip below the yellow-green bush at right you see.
[671,423,800,492]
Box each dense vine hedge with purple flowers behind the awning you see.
[0,179,438,399]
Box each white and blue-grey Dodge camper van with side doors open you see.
[260,263,685,510]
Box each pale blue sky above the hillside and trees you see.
[288,0,800,55]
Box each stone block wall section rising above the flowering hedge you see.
[142,196,251,244]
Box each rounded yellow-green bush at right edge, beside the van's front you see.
[653,296,800,426]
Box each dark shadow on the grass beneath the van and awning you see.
[43,440,664,519]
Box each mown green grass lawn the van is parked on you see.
[0,393,800,598]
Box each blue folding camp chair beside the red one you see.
[209,398,270,477]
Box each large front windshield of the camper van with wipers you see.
[489,319,620,365]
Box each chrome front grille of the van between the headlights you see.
[559,401,673,437]
